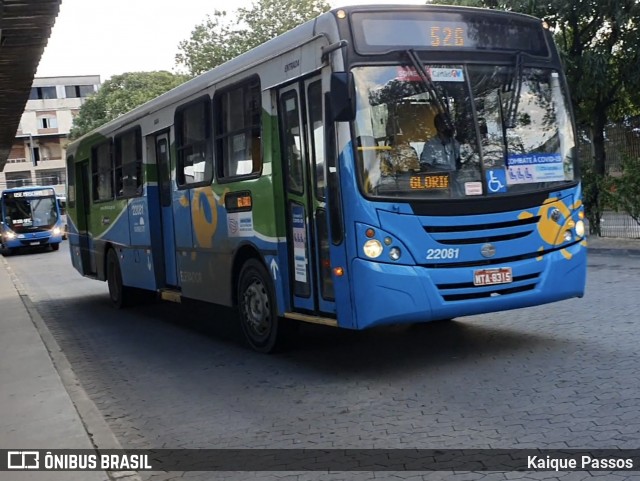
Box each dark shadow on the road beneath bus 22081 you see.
[41,290,571,378]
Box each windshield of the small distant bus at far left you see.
[4,195,58,233]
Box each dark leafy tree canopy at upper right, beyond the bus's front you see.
[433,0,640,176]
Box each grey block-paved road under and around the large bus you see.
[8,246,640,481]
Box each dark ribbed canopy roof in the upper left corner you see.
[0,0,62,170]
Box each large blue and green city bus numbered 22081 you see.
[67,1,586,352]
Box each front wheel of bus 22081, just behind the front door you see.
[238,259,289,353]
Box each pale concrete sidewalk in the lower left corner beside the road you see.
[0,258,109,481]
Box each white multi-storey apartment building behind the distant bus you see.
[0,75,100,195]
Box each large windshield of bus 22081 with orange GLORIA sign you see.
[353,61,578,199]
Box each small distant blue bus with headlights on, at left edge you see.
[0,186,64,256]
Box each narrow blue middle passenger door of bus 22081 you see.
[155,132,178,286]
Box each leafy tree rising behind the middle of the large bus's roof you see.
[176,0,330,76]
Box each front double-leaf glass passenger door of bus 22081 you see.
[279,77,336,317]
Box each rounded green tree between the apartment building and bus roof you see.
[69,71,188,139]
